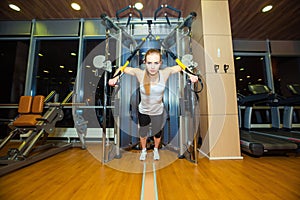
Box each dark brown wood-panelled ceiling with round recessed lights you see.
[0,0,300,40]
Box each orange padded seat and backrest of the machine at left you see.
[13,95,45,127]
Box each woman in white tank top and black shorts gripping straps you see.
[108,49,198,161]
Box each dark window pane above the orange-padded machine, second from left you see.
[32,40,79,101]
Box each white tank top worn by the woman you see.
[139,72,166,115]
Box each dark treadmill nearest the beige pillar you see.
[238,84,298,157]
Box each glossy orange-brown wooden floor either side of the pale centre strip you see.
[0,145,300,200]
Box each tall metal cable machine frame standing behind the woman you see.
[73,7,203,163]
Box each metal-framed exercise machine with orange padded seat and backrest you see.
[0,91,73,176]
